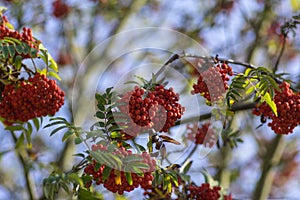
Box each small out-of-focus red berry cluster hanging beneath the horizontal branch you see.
[187,123,216,147]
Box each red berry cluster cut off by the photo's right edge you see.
[252,82,300,134]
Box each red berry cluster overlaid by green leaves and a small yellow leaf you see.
[84,144,156,194]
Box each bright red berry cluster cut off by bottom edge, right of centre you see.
[189,183,221,200]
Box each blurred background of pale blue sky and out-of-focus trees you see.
[0,0,300,199]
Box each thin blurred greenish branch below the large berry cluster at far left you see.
[10,131,37,200]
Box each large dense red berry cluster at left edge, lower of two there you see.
[0,73,64,125]
